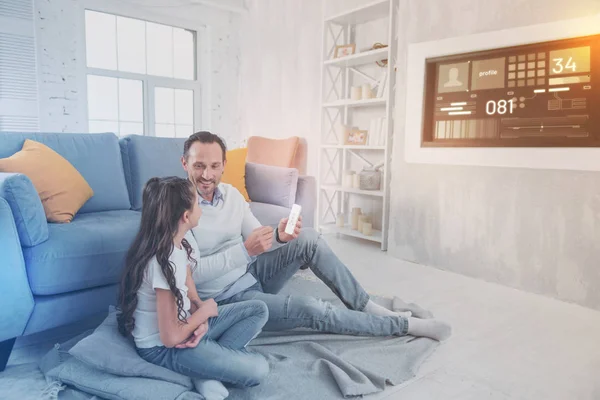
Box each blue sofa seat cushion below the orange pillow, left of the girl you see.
[23,210,141,295]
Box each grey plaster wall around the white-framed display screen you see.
[389,0,600,310]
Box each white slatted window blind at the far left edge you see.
[0,0,39,132]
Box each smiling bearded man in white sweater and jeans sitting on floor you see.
[182,132,450,340]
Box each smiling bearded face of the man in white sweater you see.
[182,142,225,199]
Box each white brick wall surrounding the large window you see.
[35,0,240,147]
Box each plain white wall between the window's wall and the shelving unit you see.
[239,0,323,175]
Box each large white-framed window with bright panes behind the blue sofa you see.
[85,10,200,137]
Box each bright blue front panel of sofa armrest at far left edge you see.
[0,197,34,342]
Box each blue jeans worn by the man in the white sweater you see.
[219,228,408,336]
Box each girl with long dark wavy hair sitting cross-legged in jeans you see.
[117,177,269,390]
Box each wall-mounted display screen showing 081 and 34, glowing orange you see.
[422,35,600,147]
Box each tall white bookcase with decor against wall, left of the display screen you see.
[315,0,399,251]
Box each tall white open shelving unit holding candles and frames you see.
[317,0,398,250]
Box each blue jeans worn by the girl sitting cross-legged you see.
[137,300,269,387]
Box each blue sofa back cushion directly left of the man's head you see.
[119,135,187,211]
